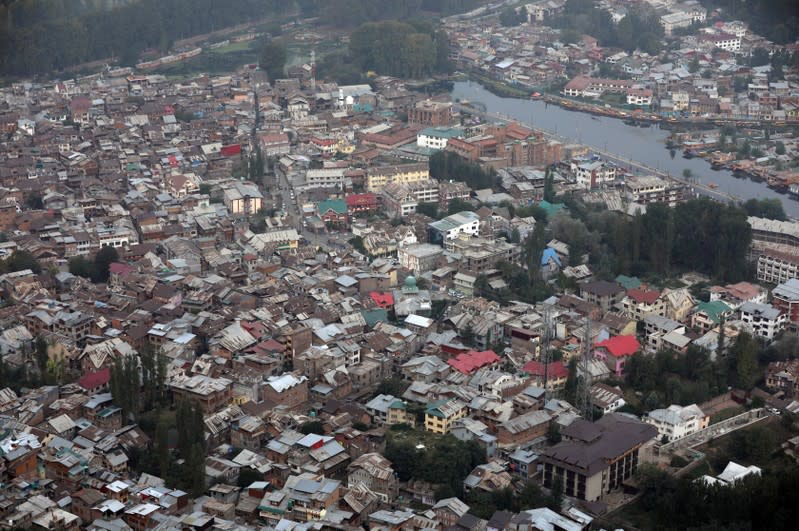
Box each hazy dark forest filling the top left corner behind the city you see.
[0,0,292,75]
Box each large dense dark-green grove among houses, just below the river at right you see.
[549,196,752,282]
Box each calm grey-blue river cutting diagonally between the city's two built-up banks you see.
[451,81,799,218]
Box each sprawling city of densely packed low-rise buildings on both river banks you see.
[0,0,799,531]
